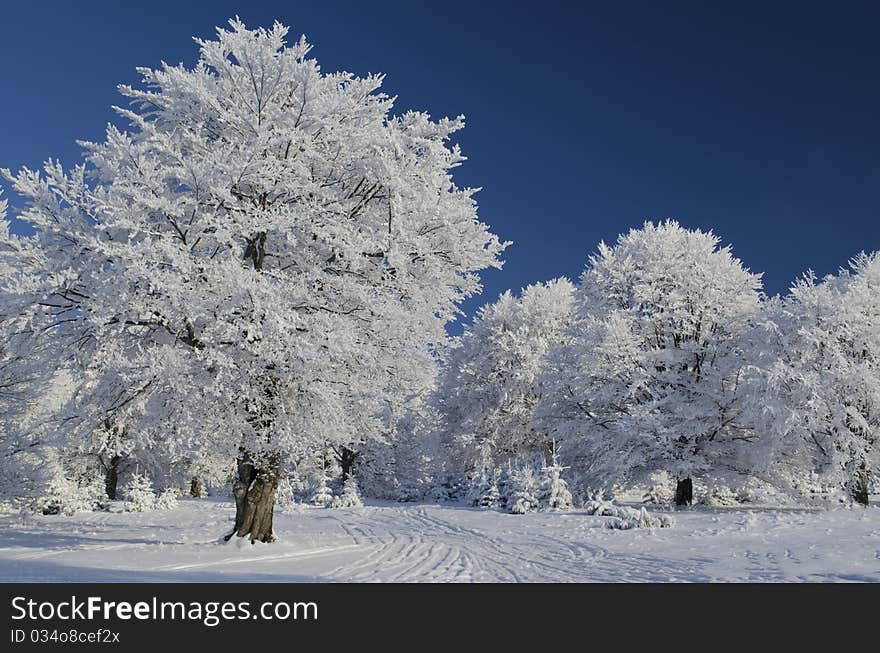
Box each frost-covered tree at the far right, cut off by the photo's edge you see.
[755,253,880,503]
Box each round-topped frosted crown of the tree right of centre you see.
[538,221,761,500]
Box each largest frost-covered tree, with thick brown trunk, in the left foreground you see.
[3,19,504,541]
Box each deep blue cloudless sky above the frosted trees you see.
[0,0,880,326]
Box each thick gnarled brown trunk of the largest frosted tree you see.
[226,454,279,542]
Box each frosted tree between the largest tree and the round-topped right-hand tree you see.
[438,279,574,473]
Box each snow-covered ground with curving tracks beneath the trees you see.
[0,499,880,582]
